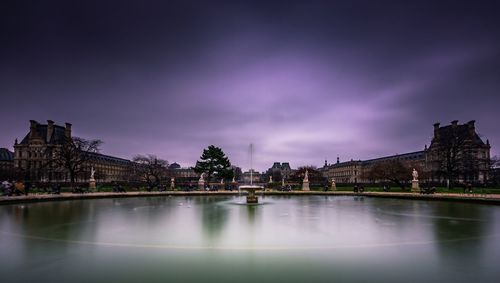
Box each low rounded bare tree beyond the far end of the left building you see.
[133,154,168,187]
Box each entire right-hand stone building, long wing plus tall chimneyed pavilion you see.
[321,121,491,183]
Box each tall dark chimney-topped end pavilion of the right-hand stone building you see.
[425,120,491,183]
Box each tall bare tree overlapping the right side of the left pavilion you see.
[52,137,102,187]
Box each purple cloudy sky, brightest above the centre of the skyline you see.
[0,0,500,170]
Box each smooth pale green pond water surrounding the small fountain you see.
[0,196,500,282]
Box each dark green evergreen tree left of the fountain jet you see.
[193,145,233,181]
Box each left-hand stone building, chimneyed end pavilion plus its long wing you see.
[14,120,132,182]
